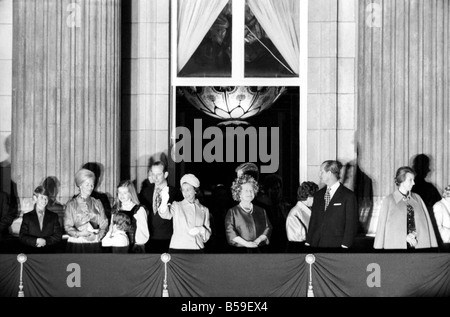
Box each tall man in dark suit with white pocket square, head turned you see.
[305,161,358,249]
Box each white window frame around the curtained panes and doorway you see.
[170,0,309,181]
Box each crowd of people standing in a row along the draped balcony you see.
[0,160,450,253]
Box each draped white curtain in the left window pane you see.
[178,0,228,72]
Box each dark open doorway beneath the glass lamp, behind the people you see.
[171,87,300,203]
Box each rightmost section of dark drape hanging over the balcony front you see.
[313,253,450,297]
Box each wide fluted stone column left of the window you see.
[12,0,122,211]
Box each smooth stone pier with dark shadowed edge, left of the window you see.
[121,0,171,191]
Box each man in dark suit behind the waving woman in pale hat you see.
[139,162,179,253]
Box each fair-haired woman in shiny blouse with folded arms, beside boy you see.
[64,169,108,253]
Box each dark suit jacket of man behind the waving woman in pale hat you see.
[139,183,179,240]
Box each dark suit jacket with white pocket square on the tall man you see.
[306,184,358,248]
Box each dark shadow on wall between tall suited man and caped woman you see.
[343,143,374,234]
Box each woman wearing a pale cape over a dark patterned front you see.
[374,166,438,250]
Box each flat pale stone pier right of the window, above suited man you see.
[308,0,338,185]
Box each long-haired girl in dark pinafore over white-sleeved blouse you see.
[113,180,150,253]
